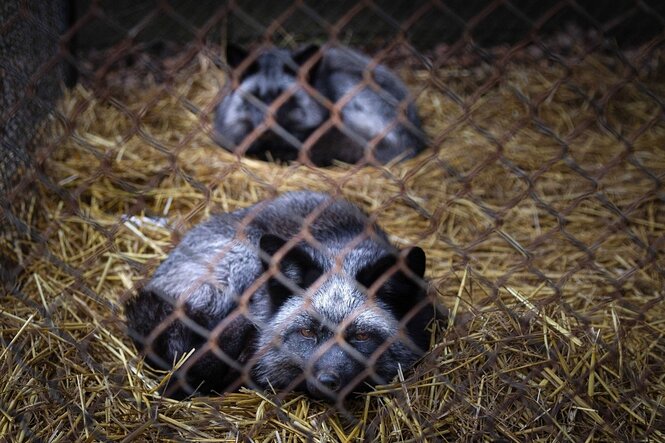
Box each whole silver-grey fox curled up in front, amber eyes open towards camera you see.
[126,191,434,399]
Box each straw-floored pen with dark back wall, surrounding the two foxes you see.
[0,0,665,441]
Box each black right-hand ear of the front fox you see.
[356,247,427,318]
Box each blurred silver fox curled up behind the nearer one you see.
[214,45,425,166]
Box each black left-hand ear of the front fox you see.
[259,234,323,308]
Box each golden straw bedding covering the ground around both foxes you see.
[0,43,665,441]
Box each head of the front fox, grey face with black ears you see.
[253,236,431,400]
